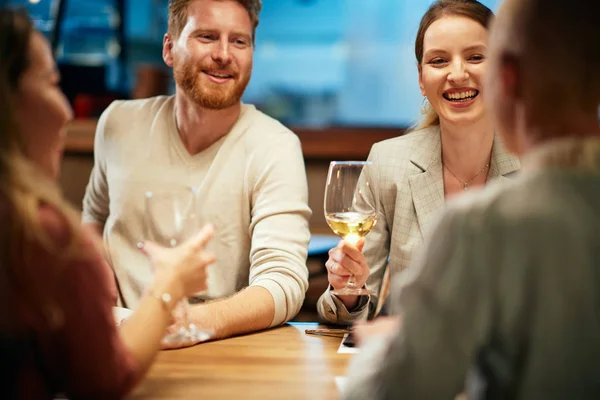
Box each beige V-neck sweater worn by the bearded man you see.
[83,96,311,326]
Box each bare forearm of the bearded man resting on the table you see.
[190,286,275,339]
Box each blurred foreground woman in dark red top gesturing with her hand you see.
[0,9,214,399]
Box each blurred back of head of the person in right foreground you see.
[495,0,600,128]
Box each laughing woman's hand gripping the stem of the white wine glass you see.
[325,238,370,310]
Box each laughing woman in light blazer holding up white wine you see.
[318,0,520,324]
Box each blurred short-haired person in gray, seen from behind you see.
[344,0,600,399]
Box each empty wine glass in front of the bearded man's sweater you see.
[145,188,212,345]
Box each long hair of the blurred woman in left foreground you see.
[0,8,85,328]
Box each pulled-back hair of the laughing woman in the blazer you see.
[412,0,494,130]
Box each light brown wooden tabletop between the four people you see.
[132,323,350,400]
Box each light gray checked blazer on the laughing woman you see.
[317,126,521,324]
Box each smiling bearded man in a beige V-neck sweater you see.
[83,0,311,346]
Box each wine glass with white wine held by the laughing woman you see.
[324,161,377,296]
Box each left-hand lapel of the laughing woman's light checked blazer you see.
[408,127,444,234]
